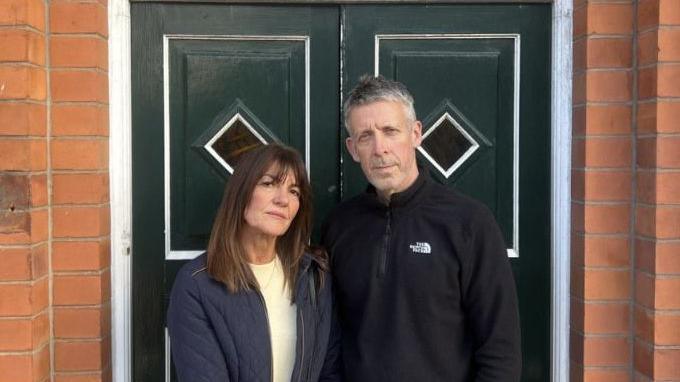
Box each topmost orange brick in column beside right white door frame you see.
[588,3,633,35]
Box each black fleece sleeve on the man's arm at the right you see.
[462,208,522,382]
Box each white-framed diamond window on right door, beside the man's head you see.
[418,112,479,178]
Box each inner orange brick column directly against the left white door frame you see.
[49,0,111,382]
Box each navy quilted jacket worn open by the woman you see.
[168,254,340,382]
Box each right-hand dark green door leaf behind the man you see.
[341,4,550,381]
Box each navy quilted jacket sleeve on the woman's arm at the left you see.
[168,270,230,382]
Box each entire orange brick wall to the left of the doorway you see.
[0,0,111,382]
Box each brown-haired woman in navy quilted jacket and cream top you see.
[168,145,339,382]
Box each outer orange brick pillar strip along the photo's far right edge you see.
[635,0,680,381]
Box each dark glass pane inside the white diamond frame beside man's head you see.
[421,119,472,170]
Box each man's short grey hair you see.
[344,74,416,134]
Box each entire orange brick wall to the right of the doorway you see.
[571,0,680,381]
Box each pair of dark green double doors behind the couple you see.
[132,3,550,381]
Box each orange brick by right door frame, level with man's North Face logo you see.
[583,235,630,267]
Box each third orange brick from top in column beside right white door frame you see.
[586,70,633,102]
